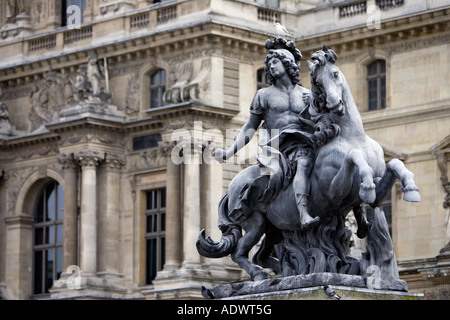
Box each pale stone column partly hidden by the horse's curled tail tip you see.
[183,147,201,269]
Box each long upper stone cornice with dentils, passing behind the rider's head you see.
[0,8,450,88]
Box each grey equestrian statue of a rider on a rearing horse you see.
[196,38,420,297]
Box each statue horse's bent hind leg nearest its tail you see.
[231,211,268,281]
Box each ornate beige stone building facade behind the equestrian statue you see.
[0,0,450,299]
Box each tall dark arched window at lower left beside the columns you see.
[33,181,64,294]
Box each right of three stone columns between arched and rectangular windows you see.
[98,153,125,274]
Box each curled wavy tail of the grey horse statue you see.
[196,193,242,258]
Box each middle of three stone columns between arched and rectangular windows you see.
[78,151,101,272]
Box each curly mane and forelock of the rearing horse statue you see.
[310,45,341,146]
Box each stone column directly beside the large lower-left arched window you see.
[58,154,78,271]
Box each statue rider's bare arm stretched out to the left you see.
[214,113,262,163]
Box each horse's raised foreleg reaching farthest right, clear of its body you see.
[372,159,420,207]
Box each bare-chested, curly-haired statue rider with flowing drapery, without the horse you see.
[216,39,319,229]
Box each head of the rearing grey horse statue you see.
[308,45,345,116]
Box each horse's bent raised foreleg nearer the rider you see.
[329,149,376,205]
